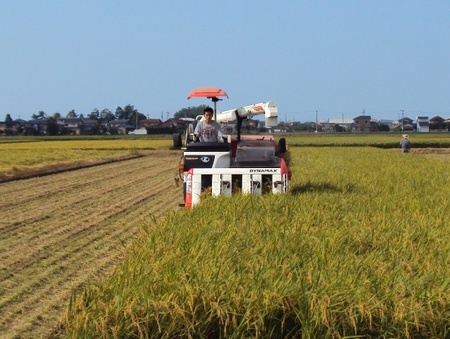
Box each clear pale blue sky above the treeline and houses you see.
[0,0,450,121]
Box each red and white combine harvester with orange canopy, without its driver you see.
[174,87,291,208]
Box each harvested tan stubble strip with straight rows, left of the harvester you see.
[0,152,182,338]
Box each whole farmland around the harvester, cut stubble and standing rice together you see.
[0,134,450,338]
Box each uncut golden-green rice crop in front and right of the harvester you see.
[63,135,450,338]
